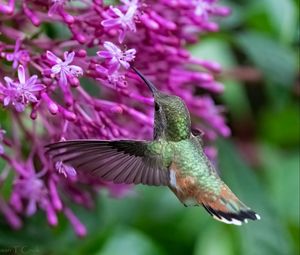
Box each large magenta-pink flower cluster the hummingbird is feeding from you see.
[0,0,230,236]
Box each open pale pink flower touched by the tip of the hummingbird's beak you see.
[97,42,136,74]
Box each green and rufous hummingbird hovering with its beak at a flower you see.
[46,67,260,225]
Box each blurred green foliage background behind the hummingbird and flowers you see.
[0,0,300,255]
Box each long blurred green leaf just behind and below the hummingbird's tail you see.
[219,142,292,255]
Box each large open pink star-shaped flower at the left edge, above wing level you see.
[0,65,45,112]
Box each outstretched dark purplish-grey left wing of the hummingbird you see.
[46,140,170,186]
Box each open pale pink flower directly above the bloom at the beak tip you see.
[101,5,137,43]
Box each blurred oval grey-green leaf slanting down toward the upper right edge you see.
[236,32,297,87]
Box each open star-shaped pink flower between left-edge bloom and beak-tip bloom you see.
[47,51,83,86]
